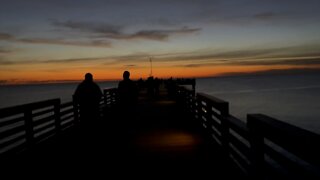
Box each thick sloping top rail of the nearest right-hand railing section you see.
[248,114,320,165]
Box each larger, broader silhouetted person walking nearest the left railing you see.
[74,73,102,125]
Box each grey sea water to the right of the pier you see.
[196,73,320,134]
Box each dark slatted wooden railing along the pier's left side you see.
[0,88,117,157]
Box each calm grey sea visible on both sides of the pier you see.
[0,73,320,134]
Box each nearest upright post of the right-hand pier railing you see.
[247,114,264,179]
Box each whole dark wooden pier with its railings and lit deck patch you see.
[0,79,320,179]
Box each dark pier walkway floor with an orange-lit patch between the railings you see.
[4,85,240,178]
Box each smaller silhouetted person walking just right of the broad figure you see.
[118,71,138,107]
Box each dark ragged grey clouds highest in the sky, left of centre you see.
[0,21,201,47]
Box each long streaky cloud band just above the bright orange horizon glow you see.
[0,44,320,68]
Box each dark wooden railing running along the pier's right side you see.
[176,86,320,179]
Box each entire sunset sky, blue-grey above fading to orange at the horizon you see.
[0,0,320,84]
